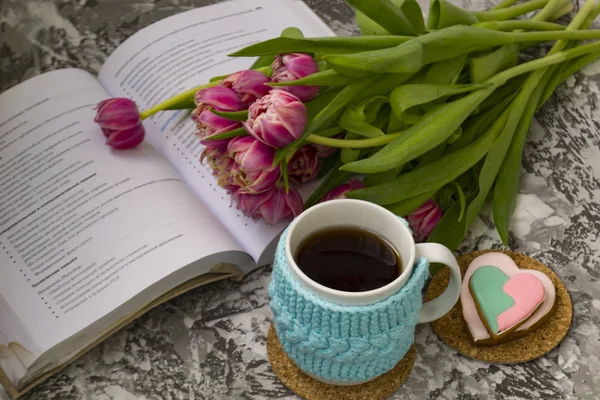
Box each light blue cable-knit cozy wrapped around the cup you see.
[269,230,429,383]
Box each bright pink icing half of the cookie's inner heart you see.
[496,272,546,332]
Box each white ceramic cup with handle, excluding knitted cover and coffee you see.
[285,199,461,323]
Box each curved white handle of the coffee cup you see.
[415,243,462,323]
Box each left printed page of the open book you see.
[0,70,248,362]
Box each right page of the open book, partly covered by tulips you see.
[99,0,333,263]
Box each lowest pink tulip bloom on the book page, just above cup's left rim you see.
[235,186,304,225]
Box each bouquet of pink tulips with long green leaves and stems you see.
[97,0,600,248]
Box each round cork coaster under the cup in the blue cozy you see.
[267,325,417,400]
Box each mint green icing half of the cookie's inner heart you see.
[469,265,515,334]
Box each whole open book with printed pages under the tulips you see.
[0,0,333,398]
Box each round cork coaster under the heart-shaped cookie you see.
[426,250,573,364]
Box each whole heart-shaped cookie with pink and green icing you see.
[461,253,556,344]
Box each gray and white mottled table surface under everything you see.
[0,0,600,400]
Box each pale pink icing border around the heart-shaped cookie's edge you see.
[460,252,556,342]
